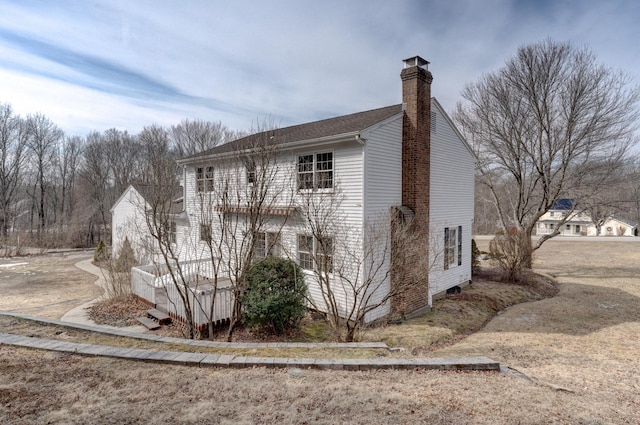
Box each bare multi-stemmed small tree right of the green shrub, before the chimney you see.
[297,182,441,342]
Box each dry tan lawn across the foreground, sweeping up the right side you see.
[0,241,640,425]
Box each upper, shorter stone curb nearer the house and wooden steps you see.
[0,311,389,350]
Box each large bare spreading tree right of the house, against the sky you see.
[455,40,639,278]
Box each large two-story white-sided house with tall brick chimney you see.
[120,56,475,321]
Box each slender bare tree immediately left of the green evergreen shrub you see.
[214,123,295,341]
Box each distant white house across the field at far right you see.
[536,199,638,236]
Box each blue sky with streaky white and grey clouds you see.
[0,0,640,135]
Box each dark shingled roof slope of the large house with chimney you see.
[179,104,402,162]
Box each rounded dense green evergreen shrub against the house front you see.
[242,258,307,334]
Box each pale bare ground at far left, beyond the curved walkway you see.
[0,252,102,319]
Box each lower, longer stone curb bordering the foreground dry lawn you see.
[0,333,500,372]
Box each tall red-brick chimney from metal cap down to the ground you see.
[391,56,433,319]
